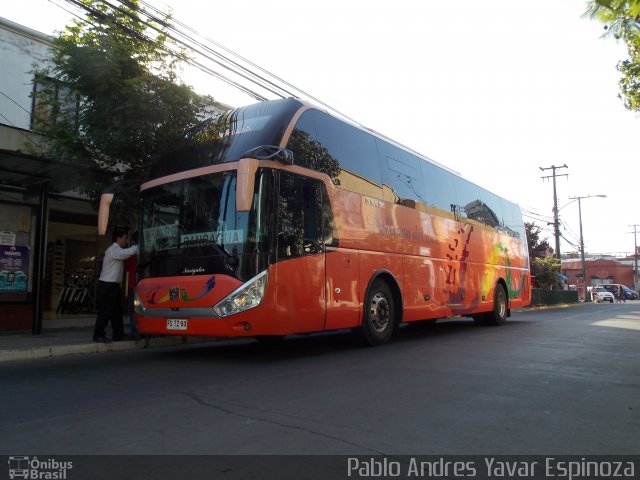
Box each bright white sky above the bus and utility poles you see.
[0,0,640,255]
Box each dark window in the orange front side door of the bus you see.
[278,171,324,259]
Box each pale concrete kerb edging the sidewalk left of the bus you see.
[0,337,191,363]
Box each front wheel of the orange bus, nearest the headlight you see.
[354,279,396,346]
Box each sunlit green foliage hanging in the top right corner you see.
[585,0,640,111]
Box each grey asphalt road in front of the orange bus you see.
[0,302,640,455]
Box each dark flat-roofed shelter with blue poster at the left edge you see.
[0,149,108,335]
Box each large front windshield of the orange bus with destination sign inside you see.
[139,170,270,279]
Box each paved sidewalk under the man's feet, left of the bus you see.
[0,315,212,363]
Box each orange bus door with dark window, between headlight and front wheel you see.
[274,170,327,333]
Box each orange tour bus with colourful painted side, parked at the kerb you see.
[99,99,531,345]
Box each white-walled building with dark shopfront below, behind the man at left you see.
[0,17,230,334]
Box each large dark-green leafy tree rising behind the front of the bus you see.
[36,0,222,227]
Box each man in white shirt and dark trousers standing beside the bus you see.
[93,229,138,343]
